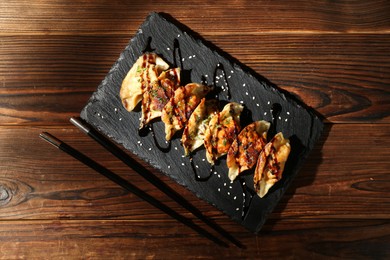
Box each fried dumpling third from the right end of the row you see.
[204,102,244,164]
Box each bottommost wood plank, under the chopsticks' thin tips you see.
[0,219,390,259]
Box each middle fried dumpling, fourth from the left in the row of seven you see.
[181,98,218,156]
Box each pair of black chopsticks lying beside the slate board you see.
[40,118,244,248]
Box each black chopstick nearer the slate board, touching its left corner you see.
[70,117,245,248]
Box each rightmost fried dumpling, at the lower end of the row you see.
[253,133,291,198]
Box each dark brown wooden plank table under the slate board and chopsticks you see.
[0,0,390,259]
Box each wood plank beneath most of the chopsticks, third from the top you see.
[0,124,390,221]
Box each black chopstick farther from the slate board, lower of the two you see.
[39,132,229,247]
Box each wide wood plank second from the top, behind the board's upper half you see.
[0,34,390,125]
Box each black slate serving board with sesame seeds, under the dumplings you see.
[81,13,323,233]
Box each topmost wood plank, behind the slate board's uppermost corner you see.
[0,0,390,35]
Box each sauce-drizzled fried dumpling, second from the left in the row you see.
[140,68,180,128]
